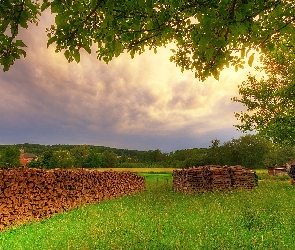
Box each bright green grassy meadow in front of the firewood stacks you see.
[0,172,295,250]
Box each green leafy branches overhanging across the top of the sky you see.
[0,0,295,80]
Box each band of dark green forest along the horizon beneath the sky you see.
[0,135,295,169]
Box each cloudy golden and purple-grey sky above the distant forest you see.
[0,13,260,153]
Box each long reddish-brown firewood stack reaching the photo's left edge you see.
[0,168,145,230]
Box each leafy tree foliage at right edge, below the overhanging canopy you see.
[233,40,295,146]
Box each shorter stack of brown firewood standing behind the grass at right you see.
[172,165,255,193]
